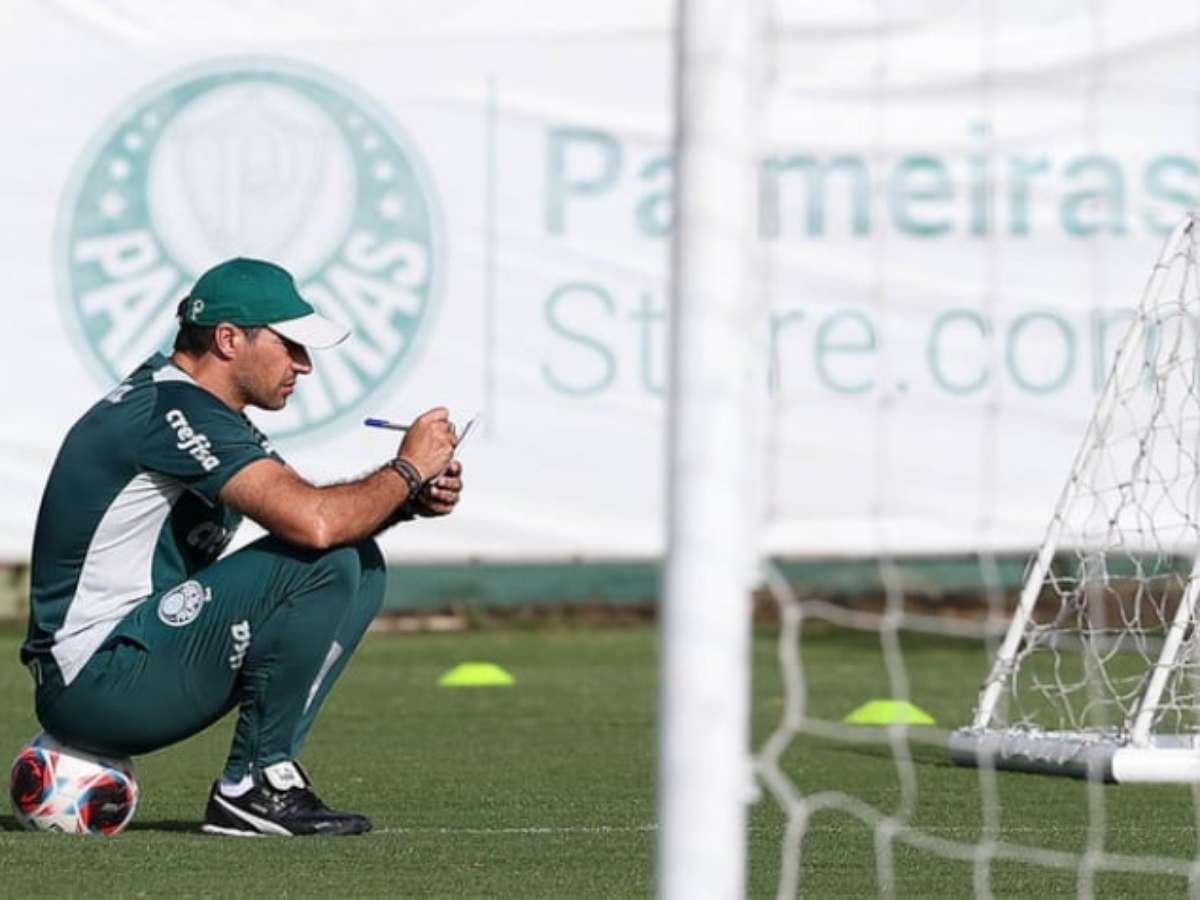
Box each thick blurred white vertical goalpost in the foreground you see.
[658,0,766,900]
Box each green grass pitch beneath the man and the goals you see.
[0,626,1198,898]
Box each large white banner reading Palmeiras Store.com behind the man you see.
[0,0,1200,560]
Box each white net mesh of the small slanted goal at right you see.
[984,216,1200,738]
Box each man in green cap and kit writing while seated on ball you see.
[20,258,462,835]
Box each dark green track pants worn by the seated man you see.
[37,536,386,779]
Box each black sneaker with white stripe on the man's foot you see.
[200,762,371,838]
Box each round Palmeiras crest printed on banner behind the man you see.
[55,60,442,437]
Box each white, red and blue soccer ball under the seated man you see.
[8,732,138,834]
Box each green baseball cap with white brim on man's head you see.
[182,257,350,349]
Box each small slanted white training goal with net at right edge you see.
[949,211,1200,782]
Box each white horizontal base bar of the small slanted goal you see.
[947,728,1200,784]
